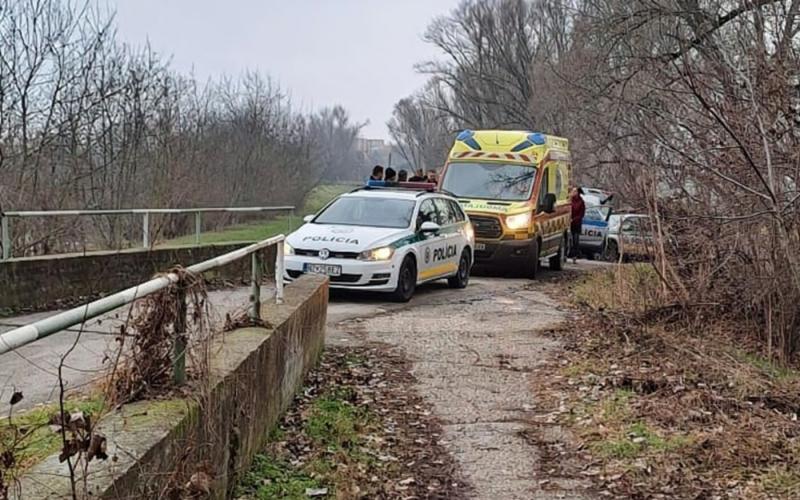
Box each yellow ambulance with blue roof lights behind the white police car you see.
[439,130,572,278]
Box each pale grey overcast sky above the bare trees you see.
[108,0,459,139]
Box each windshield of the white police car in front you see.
[313,196,415,229]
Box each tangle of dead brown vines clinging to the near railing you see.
[107,268,211,405]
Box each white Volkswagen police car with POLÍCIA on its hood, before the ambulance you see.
[284,181,475,302]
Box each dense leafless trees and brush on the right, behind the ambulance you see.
[400,0,800,358]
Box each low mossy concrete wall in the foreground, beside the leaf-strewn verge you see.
[19,276,328,499]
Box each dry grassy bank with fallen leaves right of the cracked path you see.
[537,266,800,498]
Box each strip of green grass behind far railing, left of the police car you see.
[159,184,354,246]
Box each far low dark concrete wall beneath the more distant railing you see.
[0,242,275,314]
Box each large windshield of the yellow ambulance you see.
[442,162,536,201]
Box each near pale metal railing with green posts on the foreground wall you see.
[0,234,286,383]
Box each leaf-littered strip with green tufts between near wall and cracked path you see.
[238,344,471,500]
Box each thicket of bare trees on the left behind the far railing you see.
[0,0,361,255]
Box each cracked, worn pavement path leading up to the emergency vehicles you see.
[329,278,596,499]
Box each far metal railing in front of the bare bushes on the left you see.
[0,205,295,260]
